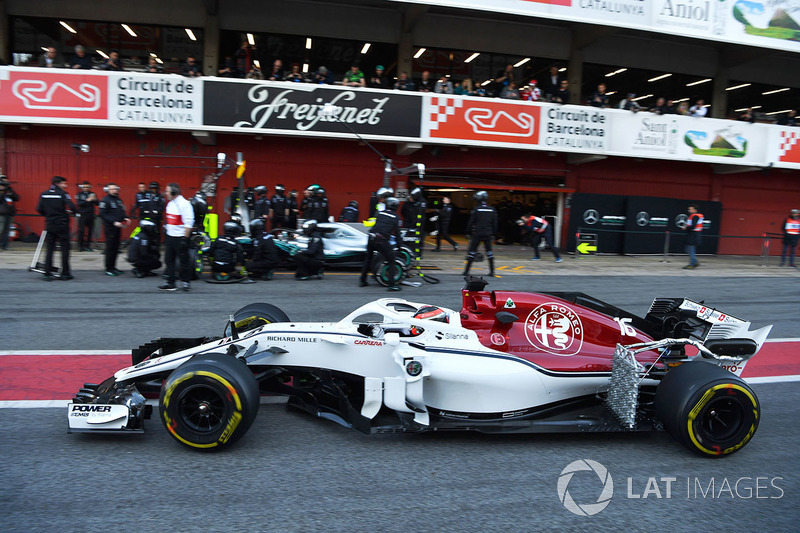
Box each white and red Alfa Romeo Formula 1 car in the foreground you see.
[68,277,772,456]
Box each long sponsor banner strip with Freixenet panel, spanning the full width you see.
[0,67,800,169]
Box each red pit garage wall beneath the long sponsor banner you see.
[0,126,800,254]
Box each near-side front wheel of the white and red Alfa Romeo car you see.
[159,353,259,451]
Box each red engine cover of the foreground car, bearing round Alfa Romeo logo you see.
[461,290,655,372]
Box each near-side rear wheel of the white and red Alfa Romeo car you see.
[655,361,761,457]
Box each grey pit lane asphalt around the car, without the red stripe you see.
[0,248,800,532]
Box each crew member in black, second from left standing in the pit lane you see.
[36,176,76,281]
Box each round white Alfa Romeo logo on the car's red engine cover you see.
[525,302,583,356]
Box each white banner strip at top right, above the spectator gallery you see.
[393,0,800,52]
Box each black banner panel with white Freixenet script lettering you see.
[204,81,422,138]
